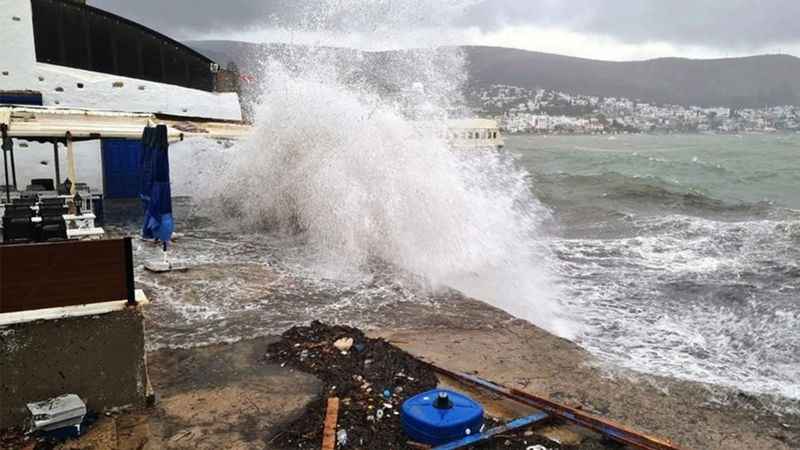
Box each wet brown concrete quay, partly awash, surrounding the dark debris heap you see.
[40,202,800,450]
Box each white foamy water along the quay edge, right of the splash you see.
[554,215,800,401]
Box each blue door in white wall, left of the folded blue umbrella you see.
[102,139,142,198]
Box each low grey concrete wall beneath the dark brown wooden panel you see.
[0,308,148,429]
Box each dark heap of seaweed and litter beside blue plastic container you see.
[265,321,588,450]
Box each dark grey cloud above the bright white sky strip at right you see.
[462,0,800,48]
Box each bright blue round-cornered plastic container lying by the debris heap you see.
[400,389,483,445]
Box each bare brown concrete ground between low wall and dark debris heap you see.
[39,338,320,450]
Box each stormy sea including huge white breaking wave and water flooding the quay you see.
[114,0,800,414]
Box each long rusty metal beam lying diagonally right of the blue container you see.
[426,363,681,450]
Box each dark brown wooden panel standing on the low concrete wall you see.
[0,239,129,313]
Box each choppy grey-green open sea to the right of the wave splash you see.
[508,135,800,400]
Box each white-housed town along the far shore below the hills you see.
[468,85,800,134]
